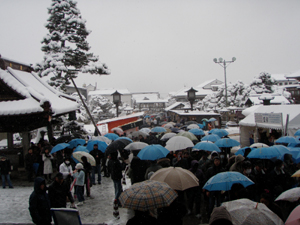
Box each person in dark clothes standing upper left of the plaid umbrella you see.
[108,152,123,205]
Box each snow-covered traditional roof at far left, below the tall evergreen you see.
[0,67,78,116]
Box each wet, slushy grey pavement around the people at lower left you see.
[0,174,207,225]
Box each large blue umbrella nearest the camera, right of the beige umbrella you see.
[203,172,254,191]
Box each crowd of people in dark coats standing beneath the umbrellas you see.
[25,122,298,224]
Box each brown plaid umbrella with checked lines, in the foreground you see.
[119,180,178,211]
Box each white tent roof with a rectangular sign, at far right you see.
[239,105,300,129]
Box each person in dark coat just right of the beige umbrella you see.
[186,160,204,219]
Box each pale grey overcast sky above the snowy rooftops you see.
[0,0,300,94]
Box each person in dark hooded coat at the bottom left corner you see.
[29,177,51,225]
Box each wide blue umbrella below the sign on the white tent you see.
[247,146,291,160]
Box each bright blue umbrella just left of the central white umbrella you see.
[137,145,170,160]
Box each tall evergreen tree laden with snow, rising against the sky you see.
[35,0,109,91]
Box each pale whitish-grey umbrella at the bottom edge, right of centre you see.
[222,198,283,225]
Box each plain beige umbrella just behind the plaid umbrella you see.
[150,166,199,191]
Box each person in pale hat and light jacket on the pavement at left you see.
[73,163,85,206]
